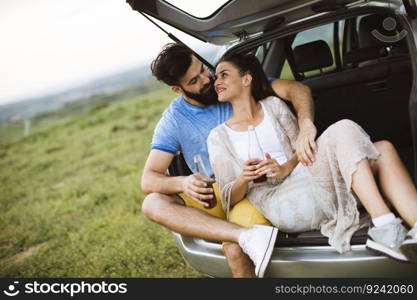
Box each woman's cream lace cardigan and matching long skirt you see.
[207,97,379,252]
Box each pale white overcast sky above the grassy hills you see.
[0,0,225,105]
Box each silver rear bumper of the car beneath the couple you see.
[173,233,417,278]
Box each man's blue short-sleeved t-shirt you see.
[151,96,232,174]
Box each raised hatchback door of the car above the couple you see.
[127,0,361,45]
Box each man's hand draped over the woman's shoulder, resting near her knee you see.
[295,119,317,166]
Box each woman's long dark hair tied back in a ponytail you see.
[217,53,277,101]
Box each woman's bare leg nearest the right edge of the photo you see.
[374,141,417,227]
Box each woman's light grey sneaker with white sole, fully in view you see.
[366,218,408,261]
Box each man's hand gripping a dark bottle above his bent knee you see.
[182,173,213,207]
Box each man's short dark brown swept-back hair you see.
[151,43,193,86]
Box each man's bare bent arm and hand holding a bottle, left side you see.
[141,149,213,206]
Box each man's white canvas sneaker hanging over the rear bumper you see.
[239,225,278,278]
